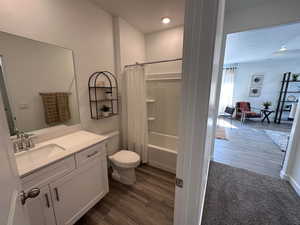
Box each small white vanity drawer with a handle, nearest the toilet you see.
[75,143,106,167]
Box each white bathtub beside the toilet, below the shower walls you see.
[148,132,178,173]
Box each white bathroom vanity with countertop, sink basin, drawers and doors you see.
[16,130,108,225]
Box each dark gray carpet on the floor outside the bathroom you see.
[202,162,300,225]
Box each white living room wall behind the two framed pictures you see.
[233,59,300,108]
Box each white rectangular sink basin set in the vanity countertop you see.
[15,144,65,172]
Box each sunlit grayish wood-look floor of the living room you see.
[214,119,291,177]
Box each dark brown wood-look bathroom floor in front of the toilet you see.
[75,165,175,225]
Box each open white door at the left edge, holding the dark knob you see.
[0,91,29,225]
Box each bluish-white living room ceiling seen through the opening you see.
[225,23,300,64]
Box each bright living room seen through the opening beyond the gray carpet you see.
[214,23,300,177]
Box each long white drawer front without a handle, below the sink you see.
[21,155,75,190]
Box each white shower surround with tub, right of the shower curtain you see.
[146,71,181,173]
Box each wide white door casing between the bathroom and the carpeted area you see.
[174,0,225,225]
